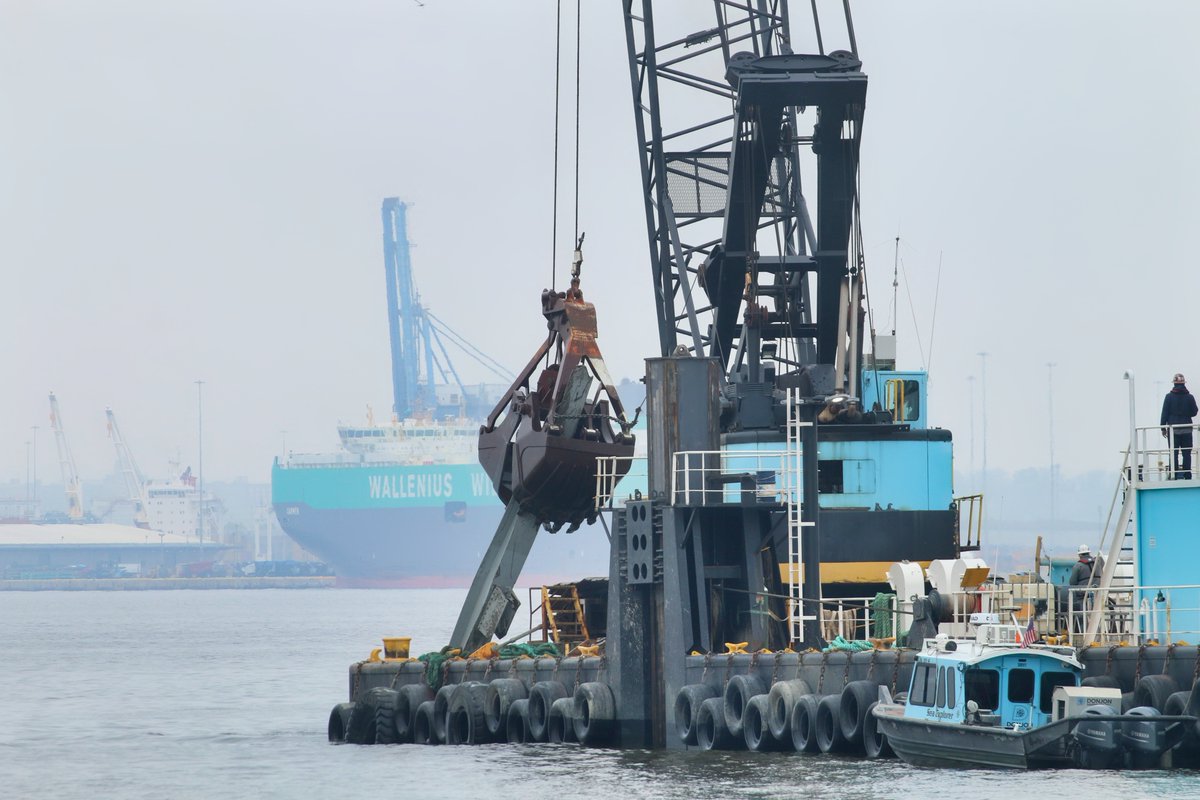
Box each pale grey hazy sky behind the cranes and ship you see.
[0,0,1200,488]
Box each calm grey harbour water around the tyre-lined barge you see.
[0,590,1200,800]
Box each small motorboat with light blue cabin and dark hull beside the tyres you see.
[872,614,1200,769]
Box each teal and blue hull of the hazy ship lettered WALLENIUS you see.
[271,464,608,587]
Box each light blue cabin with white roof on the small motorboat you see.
[904,625,1082,728]
